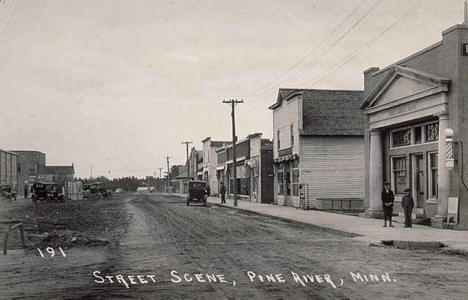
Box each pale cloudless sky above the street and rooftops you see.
[0,0,463,178]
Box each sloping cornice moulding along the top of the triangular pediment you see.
[360,65,450,109]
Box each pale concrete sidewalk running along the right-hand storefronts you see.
[162,194,468,254]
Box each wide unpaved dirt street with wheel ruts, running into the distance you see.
[0,194,468,299]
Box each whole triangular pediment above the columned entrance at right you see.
[361,66,450,110]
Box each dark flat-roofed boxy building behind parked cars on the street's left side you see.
[12,150,46,194]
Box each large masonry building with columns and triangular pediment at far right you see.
[361,24,468,229]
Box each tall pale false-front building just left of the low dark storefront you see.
[202,137,232,195]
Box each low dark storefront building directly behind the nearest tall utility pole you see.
[218,133,273,203]
